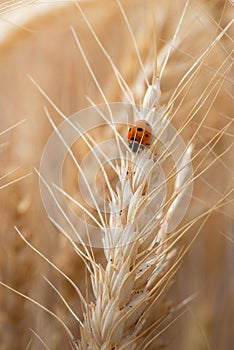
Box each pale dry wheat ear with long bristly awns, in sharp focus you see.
[1,1,232,350]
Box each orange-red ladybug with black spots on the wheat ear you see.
[128,120,152,152]
